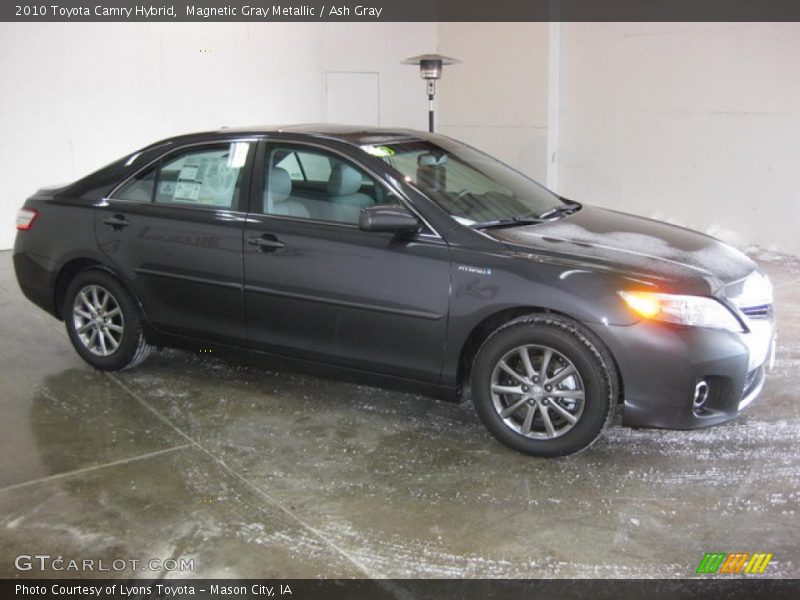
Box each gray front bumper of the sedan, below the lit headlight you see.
[590,319,775,429]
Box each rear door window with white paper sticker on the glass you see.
[113,142,251,208]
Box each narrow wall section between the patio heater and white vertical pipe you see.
[438,23,548,182]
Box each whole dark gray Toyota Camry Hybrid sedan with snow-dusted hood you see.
[14,125,775,457]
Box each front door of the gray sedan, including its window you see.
[244,142,450,382]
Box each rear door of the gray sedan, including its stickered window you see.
[95,140,256,344]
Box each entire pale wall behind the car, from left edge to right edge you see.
[0,23,800,254]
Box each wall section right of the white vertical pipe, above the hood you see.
[558,23,800,254]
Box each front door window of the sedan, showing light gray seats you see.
[262,146,392,225]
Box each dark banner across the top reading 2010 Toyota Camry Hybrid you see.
[0,0,800,22]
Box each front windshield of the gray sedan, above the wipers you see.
[362,138,563,226]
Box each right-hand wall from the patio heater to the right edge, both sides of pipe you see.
[438,23,800,254]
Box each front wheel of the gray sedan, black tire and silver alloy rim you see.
[472,314,617,458]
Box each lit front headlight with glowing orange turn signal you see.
[618,291,743,332]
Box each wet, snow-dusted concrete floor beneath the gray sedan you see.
[0,246,800,578]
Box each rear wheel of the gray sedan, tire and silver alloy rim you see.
[62,269,152,371]
